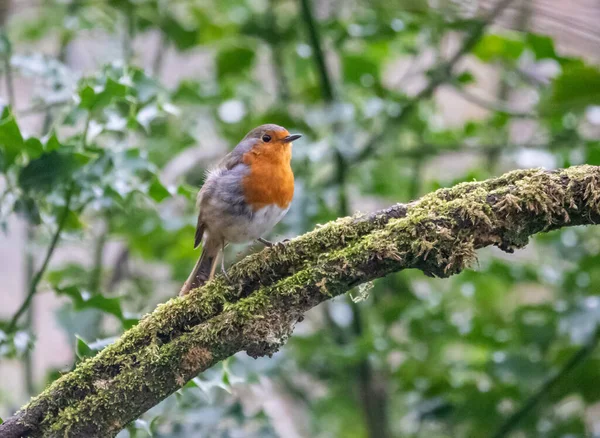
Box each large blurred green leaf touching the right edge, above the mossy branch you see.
[540,64,600,114]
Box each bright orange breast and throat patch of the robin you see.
[242,145,294,211]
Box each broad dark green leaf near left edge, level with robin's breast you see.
[19,151,74,193]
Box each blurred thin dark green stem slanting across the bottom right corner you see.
[494,326,600,438]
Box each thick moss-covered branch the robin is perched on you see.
[0,166,600,438]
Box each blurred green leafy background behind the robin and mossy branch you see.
[0,0,600,438]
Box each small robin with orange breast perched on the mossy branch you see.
[179,124,301,295]
